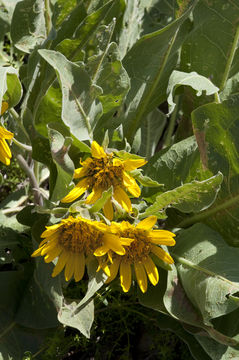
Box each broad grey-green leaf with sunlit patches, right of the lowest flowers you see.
[173,224,239,326]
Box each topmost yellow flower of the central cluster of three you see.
[61,141,147,220]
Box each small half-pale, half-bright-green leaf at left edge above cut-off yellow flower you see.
[0,66,22,108]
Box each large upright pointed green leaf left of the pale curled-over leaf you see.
[119,1,197,143]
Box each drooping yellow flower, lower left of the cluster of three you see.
[32,216,131,281]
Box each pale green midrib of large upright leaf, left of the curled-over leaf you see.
[126,29,178,143]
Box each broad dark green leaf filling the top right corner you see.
[180,0,239,90]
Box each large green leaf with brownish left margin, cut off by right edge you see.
[183,95,239,246]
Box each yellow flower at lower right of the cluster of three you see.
[94,216,175,293]
